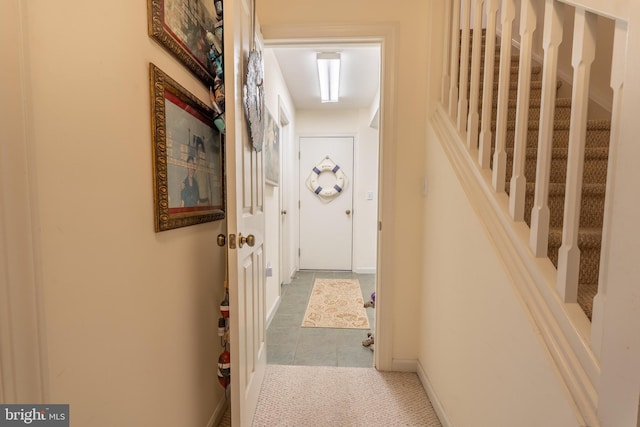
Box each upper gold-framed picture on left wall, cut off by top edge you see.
[147,0,222,87]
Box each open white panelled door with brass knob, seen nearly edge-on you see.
[225,0,267,426]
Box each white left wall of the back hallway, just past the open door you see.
[263,48,298,319]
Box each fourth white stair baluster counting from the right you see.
[509,0,537,221]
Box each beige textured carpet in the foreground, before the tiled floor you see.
[253,365,441,427]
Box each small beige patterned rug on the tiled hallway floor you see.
[302,279,369,329]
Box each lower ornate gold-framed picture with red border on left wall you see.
[149,64,225,232]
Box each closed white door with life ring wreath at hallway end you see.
[300,137,353,271]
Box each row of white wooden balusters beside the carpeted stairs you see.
[441,0,627,334]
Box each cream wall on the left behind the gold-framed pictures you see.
[0,0,225,427]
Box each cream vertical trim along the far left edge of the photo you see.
[0,2,48,404]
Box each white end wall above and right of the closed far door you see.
[296,109,379,273]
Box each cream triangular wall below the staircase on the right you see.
[419,123,578,427]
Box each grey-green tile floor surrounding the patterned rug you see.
[267,271,376,367]
